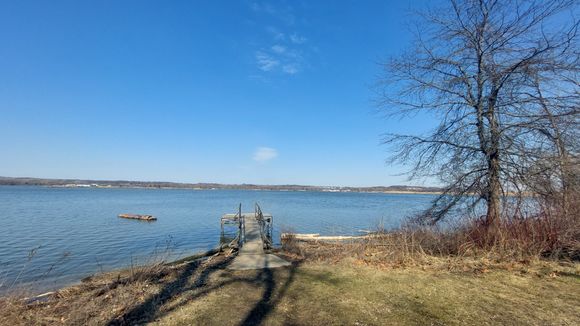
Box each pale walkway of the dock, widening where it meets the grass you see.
[228,213,290,270]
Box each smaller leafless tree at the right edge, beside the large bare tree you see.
[520,71,580,214]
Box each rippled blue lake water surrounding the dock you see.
[0,186,433,292]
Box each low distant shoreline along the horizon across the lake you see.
[0,177,442,195]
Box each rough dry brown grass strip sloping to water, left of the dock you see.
[0,255,228,325]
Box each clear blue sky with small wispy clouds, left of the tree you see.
[0,1,430,186]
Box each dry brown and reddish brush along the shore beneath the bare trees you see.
[287,199,580,271]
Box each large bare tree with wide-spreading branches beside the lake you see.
[379,0,580,228]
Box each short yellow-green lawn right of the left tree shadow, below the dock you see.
[155,259,580,325]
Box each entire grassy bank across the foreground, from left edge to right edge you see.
[0,245,580,325]
